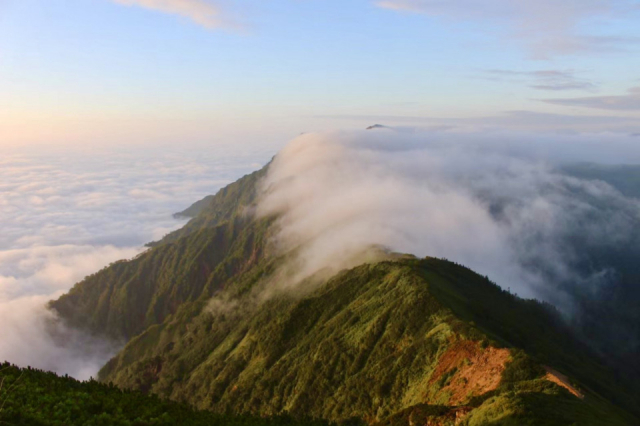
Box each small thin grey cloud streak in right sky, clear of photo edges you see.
[481,70,598,91]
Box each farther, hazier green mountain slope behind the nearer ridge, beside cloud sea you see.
[51,169,269,340]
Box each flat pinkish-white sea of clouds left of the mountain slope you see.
[0,146,273,379]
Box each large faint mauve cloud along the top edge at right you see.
[376,0,637,59]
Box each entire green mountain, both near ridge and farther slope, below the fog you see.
[45,161,640,425]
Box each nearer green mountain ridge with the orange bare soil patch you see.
[101,259,634,425]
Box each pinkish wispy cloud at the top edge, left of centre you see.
[112,0,237,29]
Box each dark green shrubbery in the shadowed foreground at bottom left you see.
[0,363,328,426]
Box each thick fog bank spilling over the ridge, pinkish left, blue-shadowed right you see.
[257,129,640,352]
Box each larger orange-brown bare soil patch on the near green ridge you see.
[429,340,510,405]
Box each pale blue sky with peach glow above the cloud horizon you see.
[0,0,640,146]
